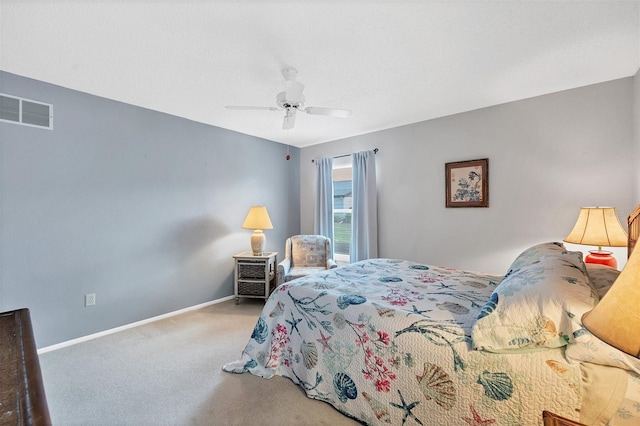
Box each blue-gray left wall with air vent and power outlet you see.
[0,73,300,347]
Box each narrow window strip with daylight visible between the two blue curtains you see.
[333,166,353,264]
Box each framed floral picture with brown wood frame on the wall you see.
[444,158,489,207]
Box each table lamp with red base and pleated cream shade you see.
[564,207,627,268]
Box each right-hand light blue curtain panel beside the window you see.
[350,151,378,263]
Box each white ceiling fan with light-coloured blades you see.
[226,67,351,130]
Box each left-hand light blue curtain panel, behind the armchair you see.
[313,158,334,259]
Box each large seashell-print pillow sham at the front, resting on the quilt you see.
[471,250,598,352]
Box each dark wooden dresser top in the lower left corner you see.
[0,309,51,426]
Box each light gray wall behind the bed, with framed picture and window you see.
[300,78,640,274]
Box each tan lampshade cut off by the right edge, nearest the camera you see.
[582,248,640,358]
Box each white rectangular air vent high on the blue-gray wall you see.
[0,93,53,129]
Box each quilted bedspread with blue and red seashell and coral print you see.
[224,259,581,425]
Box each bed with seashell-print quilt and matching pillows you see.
[223,206,640,425]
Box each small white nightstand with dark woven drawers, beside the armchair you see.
[233,251,278,305]
